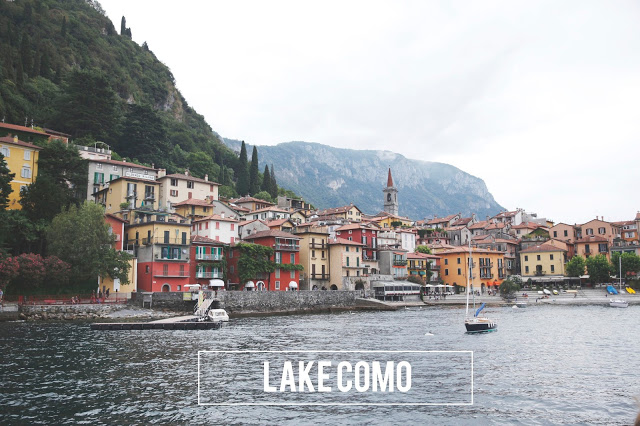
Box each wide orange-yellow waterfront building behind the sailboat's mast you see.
[438,247,506,291]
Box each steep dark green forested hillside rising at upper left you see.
[0,0,277,196]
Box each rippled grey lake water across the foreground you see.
[0,306,640,424]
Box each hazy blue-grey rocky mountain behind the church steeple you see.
[224,139,503,219]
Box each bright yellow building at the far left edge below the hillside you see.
[0,136,41,210]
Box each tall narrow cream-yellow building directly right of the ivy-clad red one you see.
[295,226,330,290]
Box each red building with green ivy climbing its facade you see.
[228,229,300,291]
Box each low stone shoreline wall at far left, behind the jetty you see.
[20,304,127,320]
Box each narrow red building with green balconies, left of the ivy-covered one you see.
[189,235,228,286]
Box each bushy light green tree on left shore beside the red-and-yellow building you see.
[47,202,131,289]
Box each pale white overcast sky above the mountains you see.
[101,0,640,223]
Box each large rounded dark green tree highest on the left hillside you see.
[55,69,119,142]
